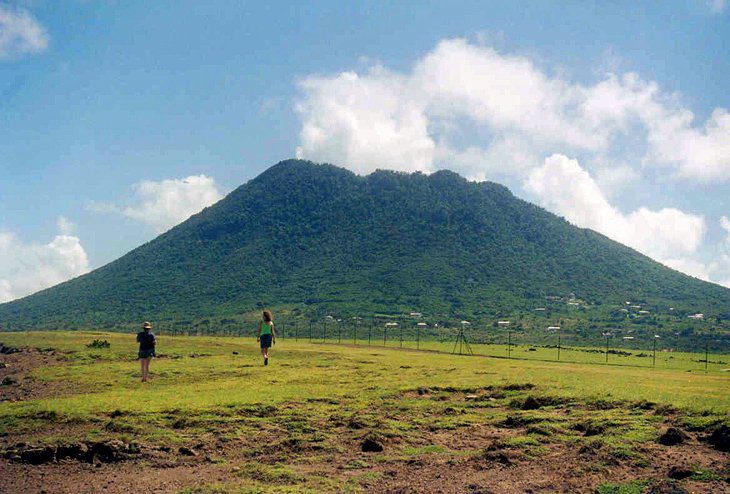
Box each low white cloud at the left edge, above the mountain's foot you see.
[0,232,89,303]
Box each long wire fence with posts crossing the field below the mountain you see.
[144,317,730,371]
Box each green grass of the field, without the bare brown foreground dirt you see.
[0,332,730,492]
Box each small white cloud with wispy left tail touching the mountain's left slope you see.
[92,175,223,233]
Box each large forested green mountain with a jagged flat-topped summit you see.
[0,160,730,327]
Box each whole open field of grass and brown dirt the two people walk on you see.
[0,332,730,492]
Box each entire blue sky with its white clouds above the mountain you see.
[0,0,730,301]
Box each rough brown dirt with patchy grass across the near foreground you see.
[0,387,730,494]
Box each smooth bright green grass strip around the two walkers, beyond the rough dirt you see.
[0,332,730,419]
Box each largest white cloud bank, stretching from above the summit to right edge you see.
[295,39,730,181]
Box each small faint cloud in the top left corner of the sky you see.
[0,5,48,60]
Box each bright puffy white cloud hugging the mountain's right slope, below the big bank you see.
[525,154,709,280]
